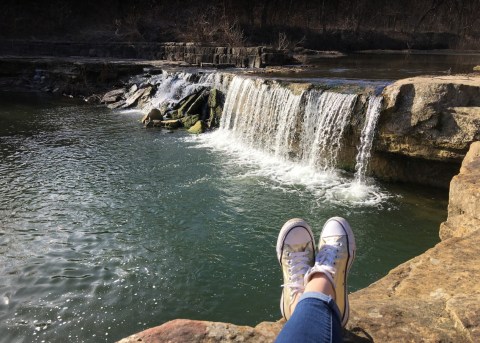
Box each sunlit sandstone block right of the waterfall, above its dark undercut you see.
[375,75,480,163]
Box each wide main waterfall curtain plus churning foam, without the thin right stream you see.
[189,75,386,206]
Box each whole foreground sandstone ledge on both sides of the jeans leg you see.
[120,142,480,343]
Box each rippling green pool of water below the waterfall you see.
[0,93,447,342]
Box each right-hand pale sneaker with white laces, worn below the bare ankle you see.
[305,217,356,326]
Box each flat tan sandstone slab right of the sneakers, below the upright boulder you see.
[348,228,480,342]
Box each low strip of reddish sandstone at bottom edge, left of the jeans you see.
[118,319,283,343]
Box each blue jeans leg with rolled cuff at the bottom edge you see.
[275,292,343,343]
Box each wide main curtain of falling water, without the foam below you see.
[220,76,357,170]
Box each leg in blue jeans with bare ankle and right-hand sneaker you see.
[276,217,356,343]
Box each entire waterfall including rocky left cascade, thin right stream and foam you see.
[128,72,385,205]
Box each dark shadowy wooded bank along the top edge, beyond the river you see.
[0,0,480,49]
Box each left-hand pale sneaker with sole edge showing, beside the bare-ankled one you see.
[277,218,315,320]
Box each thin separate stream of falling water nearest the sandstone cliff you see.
[355,96,382,183]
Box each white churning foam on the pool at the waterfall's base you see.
[185,129,390,207]
